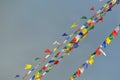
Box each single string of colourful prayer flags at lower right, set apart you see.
[69,25,120,80]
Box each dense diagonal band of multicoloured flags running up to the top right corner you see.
[30,0,120,80]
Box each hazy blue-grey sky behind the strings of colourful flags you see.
[0,0,120,80]
